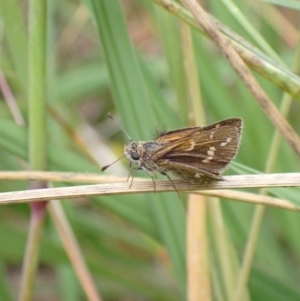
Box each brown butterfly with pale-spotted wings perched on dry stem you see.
[102,114,243,196]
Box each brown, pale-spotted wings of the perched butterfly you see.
[153,118,242,179]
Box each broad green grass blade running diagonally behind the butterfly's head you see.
[86,0,186,293]
